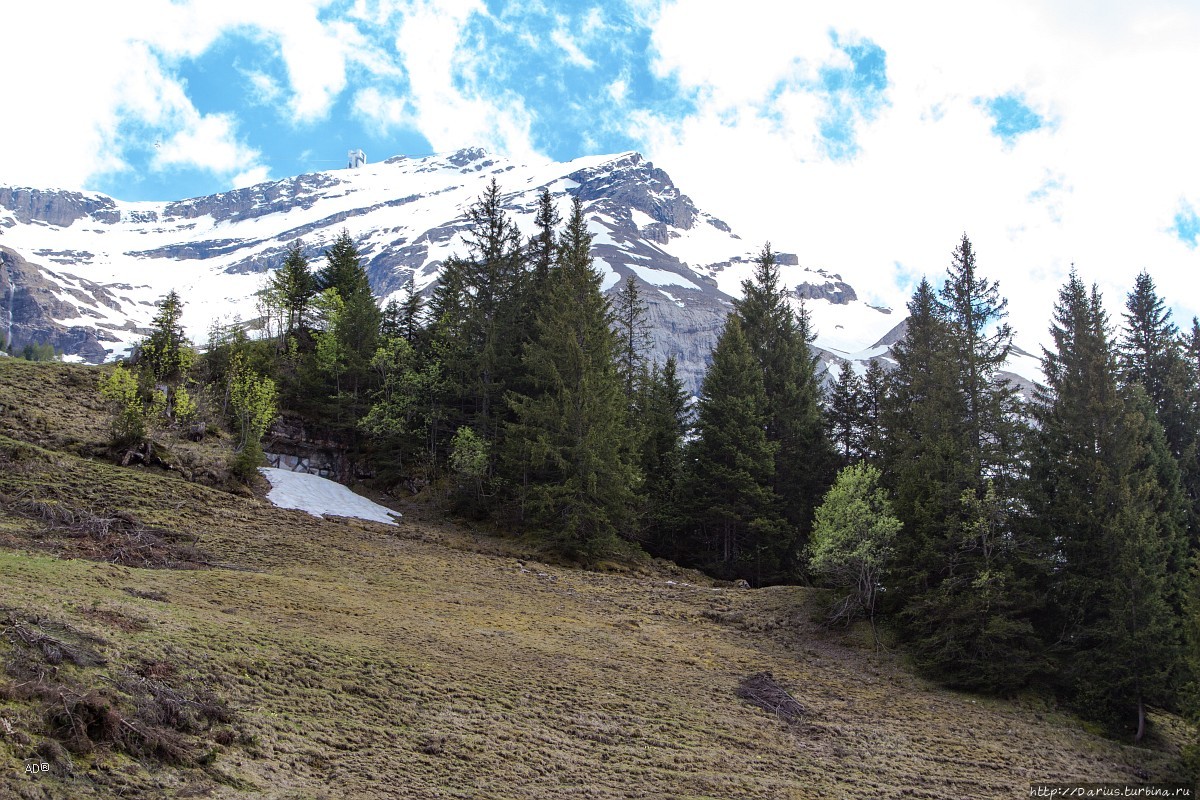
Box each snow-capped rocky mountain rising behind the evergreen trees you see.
[0,149,1032,389]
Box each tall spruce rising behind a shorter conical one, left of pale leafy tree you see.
[734,242,835,581]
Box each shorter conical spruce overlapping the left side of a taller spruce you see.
[682,314,784,583]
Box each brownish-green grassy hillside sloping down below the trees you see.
[0,359,1187,800]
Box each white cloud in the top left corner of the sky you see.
[0,0,381,188]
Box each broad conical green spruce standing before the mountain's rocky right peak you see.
[508,198,637,559]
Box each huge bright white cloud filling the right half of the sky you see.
[643,0,1200,347]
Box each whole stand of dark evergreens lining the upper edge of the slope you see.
[180,190,1200,736]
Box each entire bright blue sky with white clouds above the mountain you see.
[0,0,1200,339]
